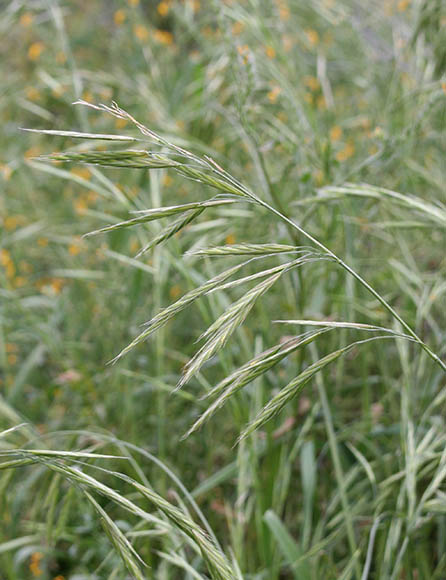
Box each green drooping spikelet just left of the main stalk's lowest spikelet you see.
[183,329,329,438]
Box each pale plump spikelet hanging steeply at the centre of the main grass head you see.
[177,270,284,389]
